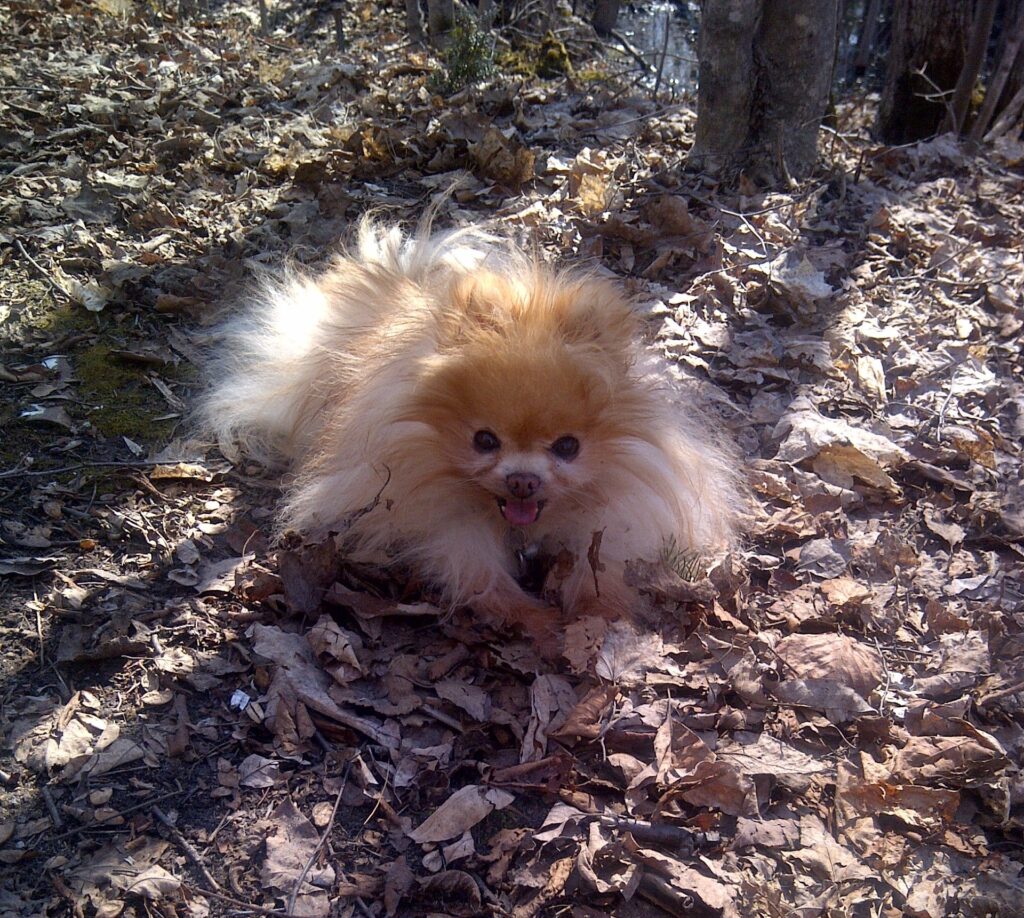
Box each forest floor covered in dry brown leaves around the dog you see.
[0,0,1024,918]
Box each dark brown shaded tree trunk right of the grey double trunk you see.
[876,0,971,143]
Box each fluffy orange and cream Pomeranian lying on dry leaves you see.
[203,219,738,649]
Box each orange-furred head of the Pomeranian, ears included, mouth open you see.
[405,275,638,527]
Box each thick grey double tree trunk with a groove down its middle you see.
[687,0,839,184]
